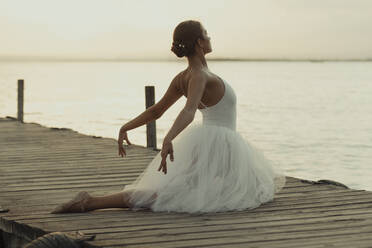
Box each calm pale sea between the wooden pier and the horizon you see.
[0,62,372,190]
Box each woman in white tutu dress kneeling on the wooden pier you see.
[52,20,285,213]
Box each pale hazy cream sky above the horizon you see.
[0,0,372,59]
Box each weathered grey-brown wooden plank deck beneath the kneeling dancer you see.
[0,116,372,248]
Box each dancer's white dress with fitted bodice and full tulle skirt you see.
[123,77,286,213]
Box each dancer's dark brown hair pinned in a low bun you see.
[171,20,203,58]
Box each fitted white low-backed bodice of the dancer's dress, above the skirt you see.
[199,79,236,130]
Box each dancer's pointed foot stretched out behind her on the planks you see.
[50,191,92,214]
